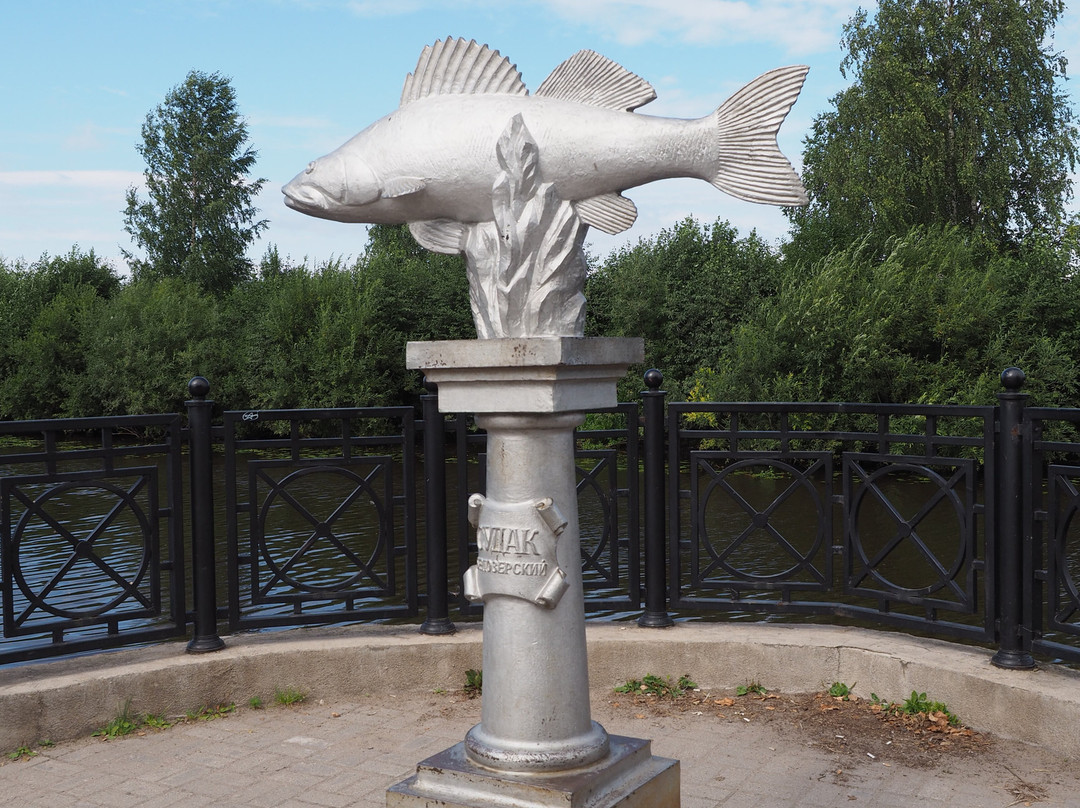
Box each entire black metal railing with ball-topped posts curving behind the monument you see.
[0,368,1080,668]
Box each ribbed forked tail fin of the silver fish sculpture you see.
[710,65,810,205]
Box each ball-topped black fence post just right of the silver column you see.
[637,368,675,629]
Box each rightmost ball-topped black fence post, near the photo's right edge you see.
[990,367,1035,670]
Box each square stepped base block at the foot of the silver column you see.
[387,736,679,808]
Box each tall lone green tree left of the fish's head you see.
[123,70,267,294]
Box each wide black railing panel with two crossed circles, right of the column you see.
[666,395,995,642]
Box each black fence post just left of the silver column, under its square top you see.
[420,379,457,634]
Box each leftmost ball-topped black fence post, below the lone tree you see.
[185,376,225,654]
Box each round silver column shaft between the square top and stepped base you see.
[465,413,608,771]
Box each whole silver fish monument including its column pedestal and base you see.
[283,39,807,808]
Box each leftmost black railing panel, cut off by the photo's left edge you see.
[0,415,187,664]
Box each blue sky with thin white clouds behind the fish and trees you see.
[0,0,1080,271]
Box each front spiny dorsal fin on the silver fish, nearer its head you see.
[401,38,529,107]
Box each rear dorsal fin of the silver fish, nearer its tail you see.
[537,51,657,112]
